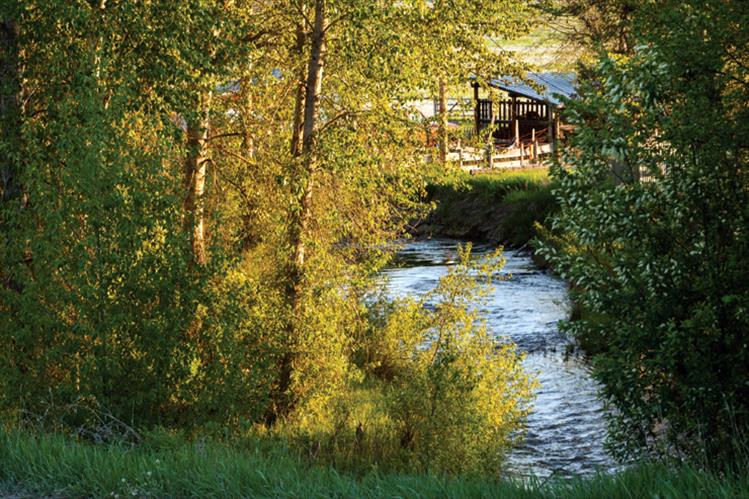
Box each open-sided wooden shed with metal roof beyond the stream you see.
[473,73,577,147]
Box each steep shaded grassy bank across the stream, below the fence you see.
[419,168,556,248]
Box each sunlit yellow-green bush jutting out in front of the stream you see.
[386,246,533,474]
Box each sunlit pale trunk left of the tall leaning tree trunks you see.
[183,92,212,265]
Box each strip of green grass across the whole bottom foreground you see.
[0,431,749,499]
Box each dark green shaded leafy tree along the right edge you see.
[543,0,749,463]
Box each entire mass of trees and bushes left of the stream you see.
[0,0,530,472]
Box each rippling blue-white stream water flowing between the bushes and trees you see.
[385,239,615,477]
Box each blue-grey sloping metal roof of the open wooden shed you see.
[489,73,577,106]
